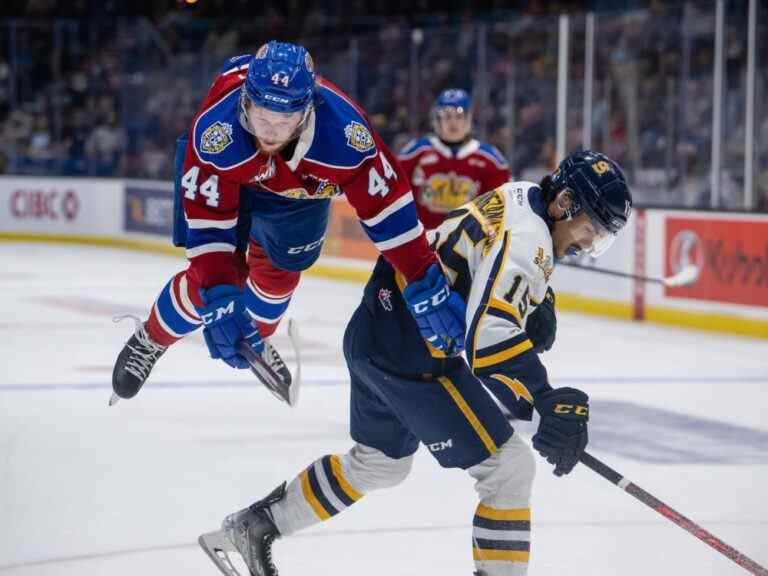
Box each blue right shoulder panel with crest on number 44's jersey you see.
[304,80,378,169]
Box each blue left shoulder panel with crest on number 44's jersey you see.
[193,84,257,170]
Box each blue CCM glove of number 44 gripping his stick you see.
[198,284,264,368]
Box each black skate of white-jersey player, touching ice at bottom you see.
[198,482,285,576]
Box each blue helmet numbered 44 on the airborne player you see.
[243,40,315,112]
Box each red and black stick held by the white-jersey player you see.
[579,452,768,576]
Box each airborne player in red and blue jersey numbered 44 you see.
[112,41,465,399]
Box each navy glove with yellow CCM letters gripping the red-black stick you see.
[533,388,589,476]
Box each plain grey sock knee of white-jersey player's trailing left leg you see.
[342,443,413,493]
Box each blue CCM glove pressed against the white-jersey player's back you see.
[403,264,467,356]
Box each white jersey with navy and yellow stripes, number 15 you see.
[430,182,554,419]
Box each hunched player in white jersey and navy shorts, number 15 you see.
[200,151,632,576]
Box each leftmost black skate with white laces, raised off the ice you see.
[109,316,168,405]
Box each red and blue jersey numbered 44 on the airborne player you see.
[181,56,435,287]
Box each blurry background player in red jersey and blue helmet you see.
[399,89,509,229]
